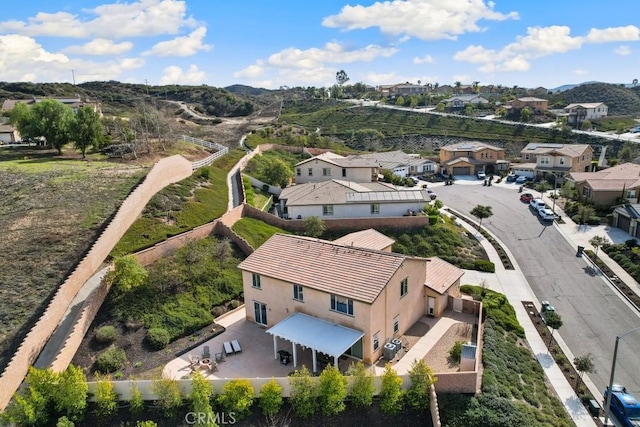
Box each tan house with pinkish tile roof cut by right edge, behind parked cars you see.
[569,163,640,206]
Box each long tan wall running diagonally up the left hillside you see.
[0,156,192,410]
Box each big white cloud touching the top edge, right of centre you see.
[322,0,518,40]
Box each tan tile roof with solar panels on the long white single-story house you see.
[279,179,429,206]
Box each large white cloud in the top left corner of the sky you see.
[0,0,194,39]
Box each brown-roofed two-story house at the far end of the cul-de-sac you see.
[440,141,509,175]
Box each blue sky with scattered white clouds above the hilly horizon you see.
[0,0,640,89]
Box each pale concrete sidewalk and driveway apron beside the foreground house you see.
[457,208,598,427]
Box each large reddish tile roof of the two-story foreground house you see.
[238,234,408,303]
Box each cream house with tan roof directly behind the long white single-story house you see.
[295,151,380,184]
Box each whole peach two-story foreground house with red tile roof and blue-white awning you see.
[239,234,463,371]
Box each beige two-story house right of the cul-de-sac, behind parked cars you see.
[520,142,593,182]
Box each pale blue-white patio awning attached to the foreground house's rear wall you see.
[267,313,364,357]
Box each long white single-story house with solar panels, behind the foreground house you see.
[279,179,430,219]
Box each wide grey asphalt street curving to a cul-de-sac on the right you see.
[434,184,640,396]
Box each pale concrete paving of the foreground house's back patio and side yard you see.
[163,306,474,379]
